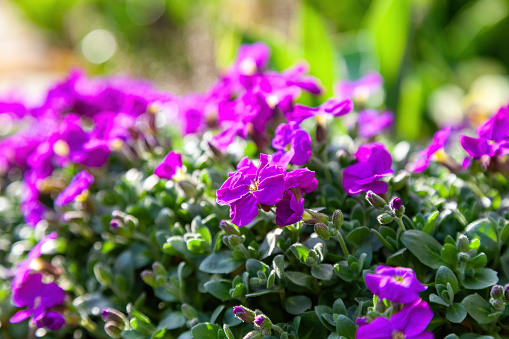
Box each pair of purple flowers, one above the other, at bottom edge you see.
[356,265,434,339]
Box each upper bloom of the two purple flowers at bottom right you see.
[366,265,428,303]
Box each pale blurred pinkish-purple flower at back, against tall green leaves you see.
[336,72,384,101]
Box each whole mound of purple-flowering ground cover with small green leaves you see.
[0,43,509,339]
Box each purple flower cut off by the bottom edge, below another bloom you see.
[355,299,434,339]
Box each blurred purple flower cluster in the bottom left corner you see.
[10,232,65,331]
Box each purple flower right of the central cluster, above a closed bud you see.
[343,143,394,194]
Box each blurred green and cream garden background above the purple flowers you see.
[0,0,509,140]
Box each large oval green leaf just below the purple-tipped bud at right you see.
[401,230,445,268]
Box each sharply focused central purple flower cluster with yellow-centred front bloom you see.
[217,153,318,226]
